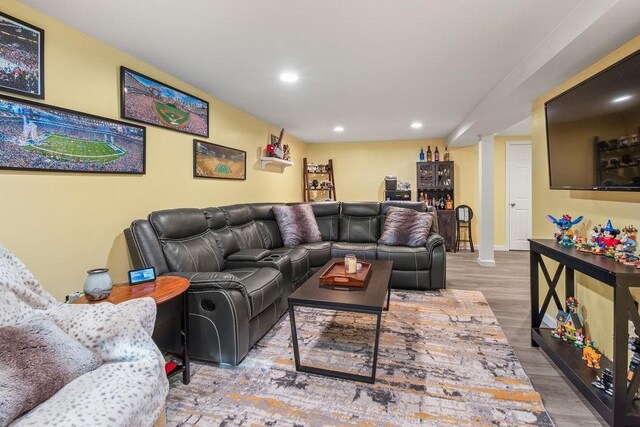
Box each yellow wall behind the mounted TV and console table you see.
[532,36,640,356]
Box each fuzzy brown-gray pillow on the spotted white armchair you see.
[0,315,101,426]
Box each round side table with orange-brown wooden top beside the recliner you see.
[73,276,191,384]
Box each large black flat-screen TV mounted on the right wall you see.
[545,51,640,191]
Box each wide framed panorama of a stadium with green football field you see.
[0,95,145,174]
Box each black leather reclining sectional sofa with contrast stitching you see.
[125,202,446,365]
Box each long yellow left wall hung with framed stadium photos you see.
[0,0,306,298]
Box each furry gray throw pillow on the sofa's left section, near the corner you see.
[273,204,322,247]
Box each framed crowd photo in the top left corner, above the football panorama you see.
[0,12,44,99]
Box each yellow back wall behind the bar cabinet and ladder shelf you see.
[307,137,530,246]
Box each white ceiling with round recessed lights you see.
[17,0,640,145]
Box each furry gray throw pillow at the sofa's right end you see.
[378,206,433,248]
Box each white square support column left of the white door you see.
[478,135,496,267]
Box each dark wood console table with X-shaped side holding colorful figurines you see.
[529,239,640,427]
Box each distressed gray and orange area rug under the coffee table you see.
[167,290,553,426]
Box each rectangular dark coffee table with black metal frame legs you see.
[289,259,393,384]
